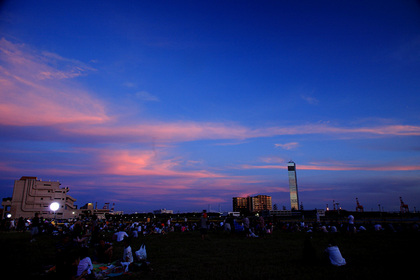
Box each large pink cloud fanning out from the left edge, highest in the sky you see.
[0,38,110,126]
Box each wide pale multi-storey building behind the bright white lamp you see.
[2,176,79,219]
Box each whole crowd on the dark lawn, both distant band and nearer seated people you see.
[1,211,419,279]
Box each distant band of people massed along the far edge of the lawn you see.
[0,211,420,237]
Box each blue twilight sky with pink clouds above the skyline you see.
[0,0,420,213]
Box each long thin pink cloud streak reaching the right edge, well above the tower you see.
[60,121,420,144]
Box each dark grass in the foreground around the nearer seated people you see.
[0,232,420,280]
